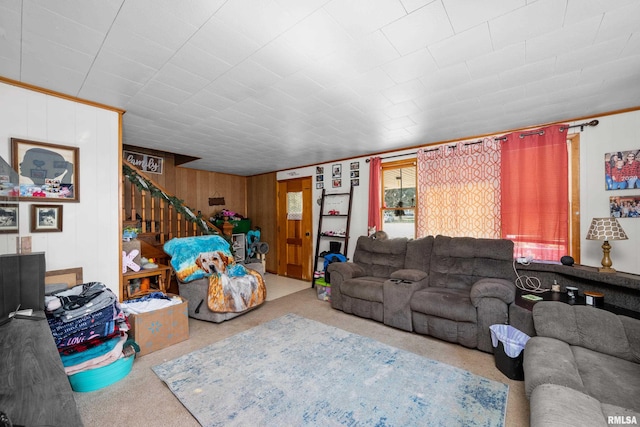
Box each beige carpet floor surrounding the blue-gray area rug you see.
[75,288,529,427]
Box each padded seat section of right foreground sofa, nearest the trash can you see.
[523,337,585,398]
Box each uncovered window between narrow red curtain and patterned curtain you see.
[381,160,417,239]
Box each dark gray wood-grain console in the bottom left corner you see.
[0,311,82,427]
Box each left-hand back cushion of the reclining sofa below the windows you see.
[353,236,407,278]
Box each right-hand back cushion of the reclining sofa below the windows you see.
[429,236,515,290]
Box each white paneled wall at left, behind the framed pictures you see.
[0,83,121,294]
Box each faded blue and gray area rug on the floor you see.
[153,314,508,426]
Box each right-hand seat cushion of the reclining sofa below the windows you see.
[411,288,477,323]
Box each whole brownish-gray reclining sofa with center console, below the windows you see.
[328,236,516,352]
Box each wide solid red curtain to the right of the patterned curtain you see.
[500,125,569,261]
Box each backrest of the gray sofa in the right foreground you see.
[533,301,640,362]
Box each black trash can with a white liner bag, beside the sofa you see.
[489,325,529,381]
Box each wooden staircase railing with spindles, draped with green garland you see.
[122,159,228,264]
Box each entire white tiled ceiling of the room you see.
[8,0,640,175]
